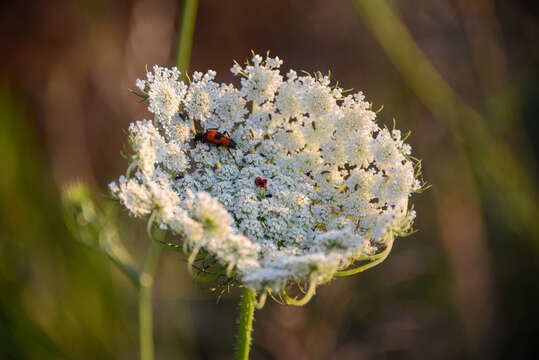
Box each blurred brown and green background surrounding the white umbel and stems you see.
[0,0,539,360]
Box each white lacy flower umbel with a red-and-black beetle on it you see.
[110,55,422,304]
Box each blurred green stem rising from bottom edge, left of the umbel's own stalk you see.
[138,239,161,360]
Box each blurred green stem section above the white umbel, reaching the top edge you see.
[176,0,198,78]
